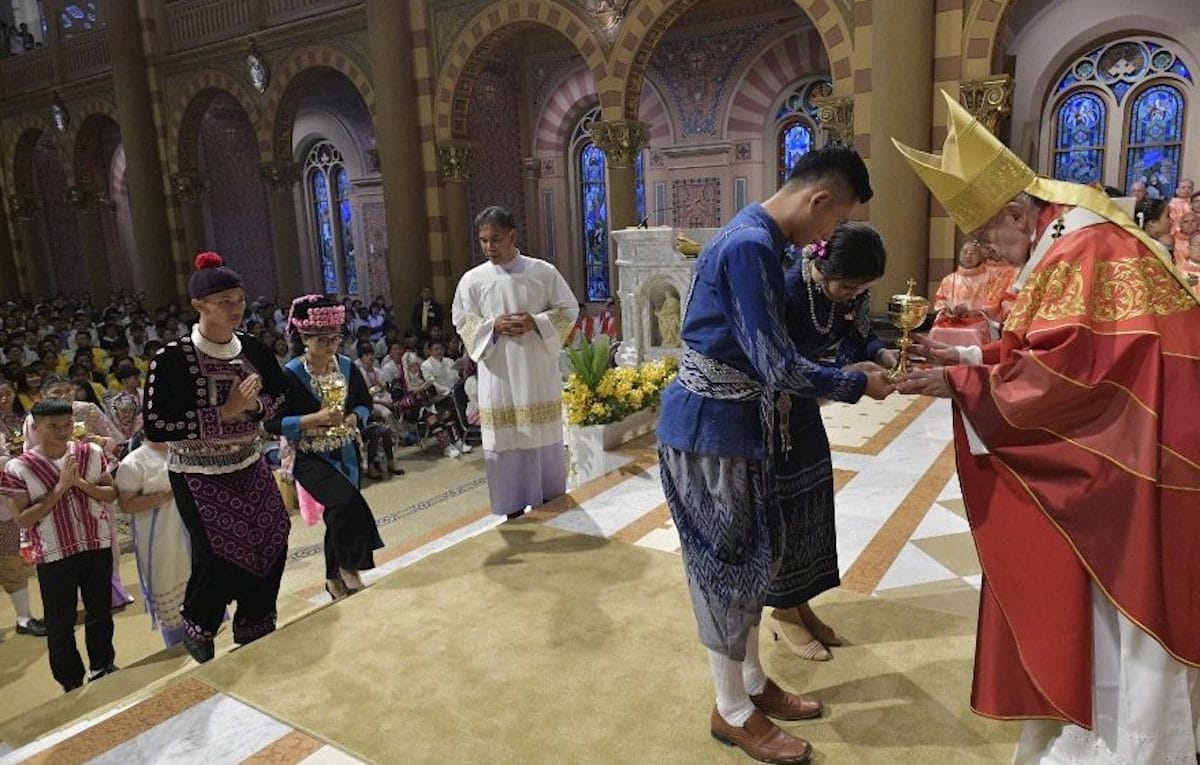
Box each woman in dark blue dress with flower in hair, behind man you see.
[767,223,896,661]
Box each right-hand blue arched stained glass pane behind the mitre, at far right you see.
[1126,83,1183,199]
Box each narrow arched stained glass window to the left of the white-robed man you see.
[305,140,360,295]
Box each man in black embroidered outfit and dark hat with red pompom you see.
[144,253,292,662]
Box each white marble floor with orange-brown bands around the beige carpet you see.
[0,396,980,764]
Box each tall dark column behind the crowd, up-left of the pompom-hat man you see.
[104,2,178,309]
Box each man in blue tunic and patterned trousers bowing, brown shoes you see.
[658,145,892,763]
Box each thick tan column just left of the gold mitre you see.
[854,0,934,305]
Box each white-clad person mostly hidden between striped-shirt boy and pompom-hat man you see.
[114,441,192,647]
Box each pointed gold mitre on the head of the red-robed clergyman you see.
[892,90,1037,234]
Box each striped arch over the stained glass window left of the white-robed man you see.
[257,46,376,162]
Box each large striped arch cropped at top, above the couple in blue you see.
[614,0,854,120]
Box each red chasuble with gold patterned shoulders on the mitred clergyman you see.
[947,213,1200,728]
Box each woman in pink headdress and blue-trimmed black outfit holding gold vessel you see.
[265,295,383,601]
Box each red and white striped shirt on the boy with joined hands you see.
[0,441,116,565]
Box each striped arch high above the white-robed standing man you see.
[433,0,605,141]
